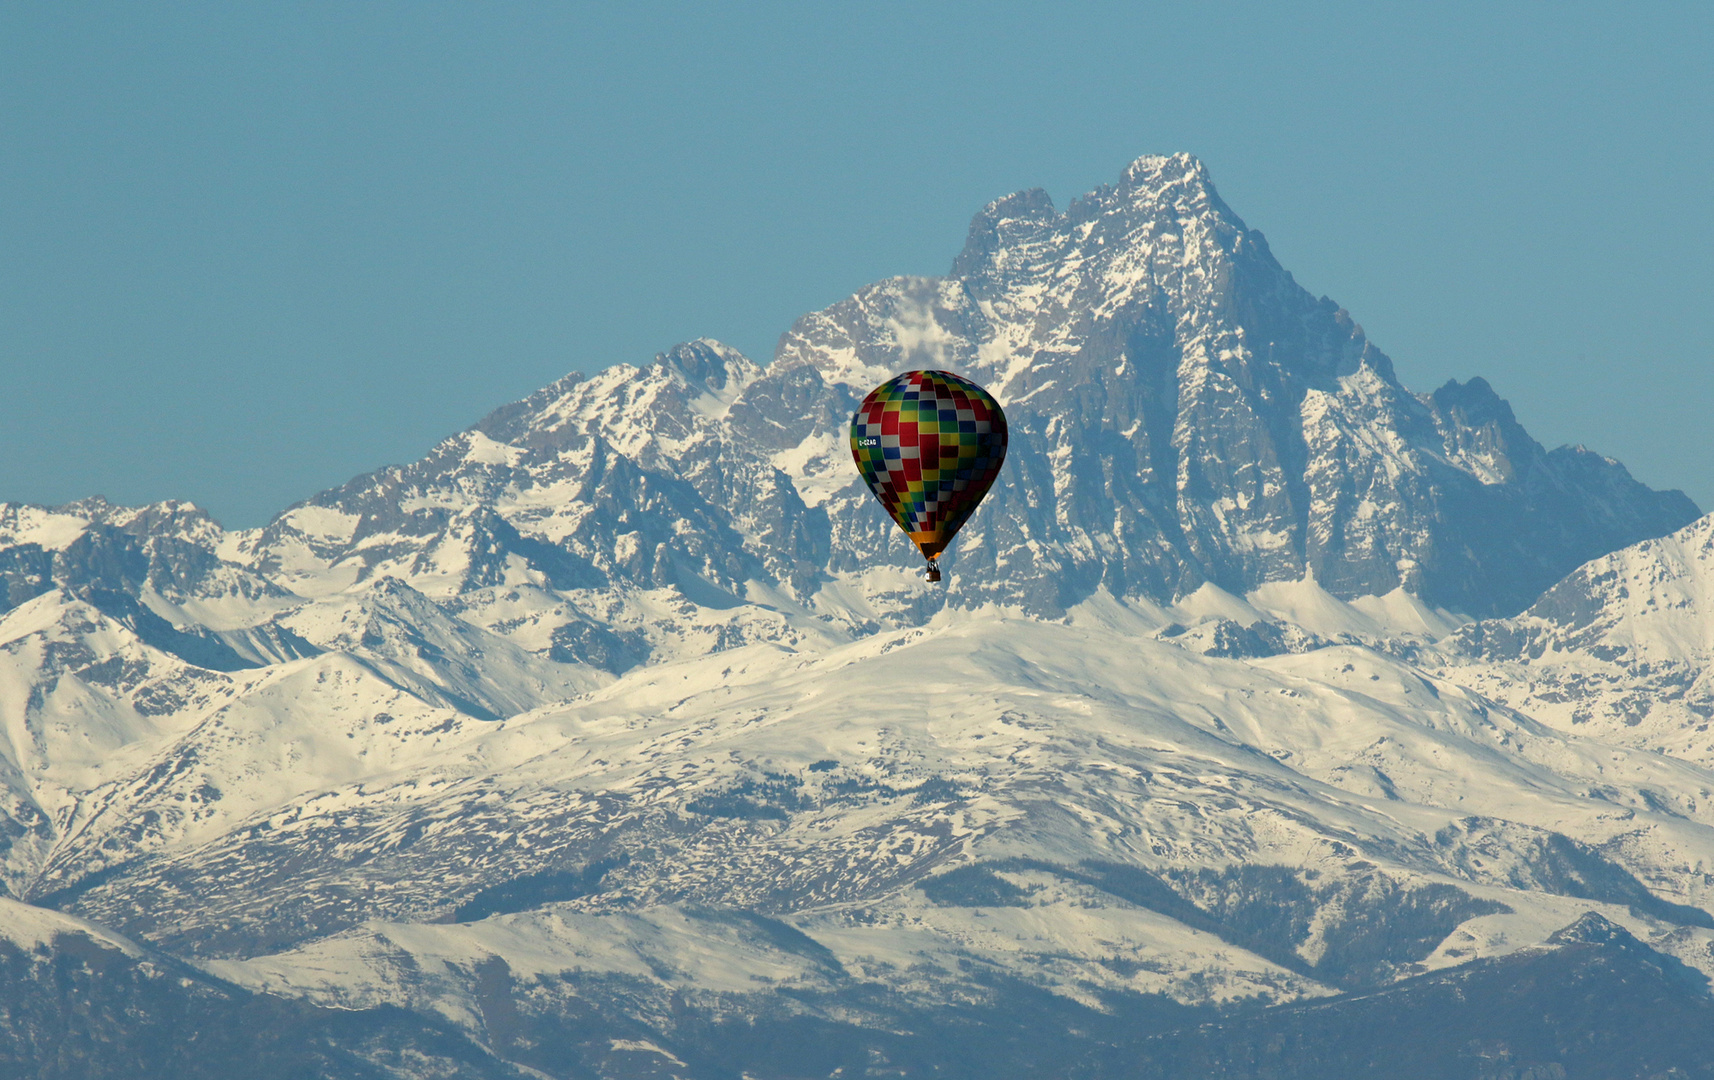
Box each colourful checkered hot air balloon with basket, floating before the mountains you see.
[852,372,1006,581]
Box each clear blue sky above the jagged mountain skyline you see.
[0,0,1714,526]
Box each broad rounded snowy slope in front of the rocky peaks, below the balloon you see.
[126,600,1714,1056]
